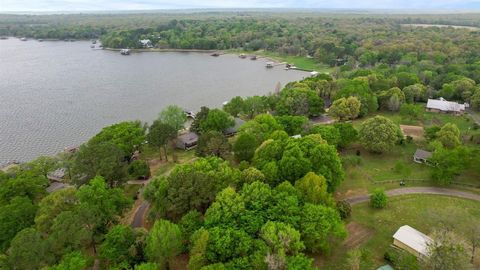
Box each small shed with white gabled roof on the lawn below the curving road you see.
[393,225,433,258]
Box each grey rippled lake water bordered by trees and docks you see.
[0,38,308,164]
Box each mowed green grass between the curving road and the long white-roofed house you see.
[336,109,480,198]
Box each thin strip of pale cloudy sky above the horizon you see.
[0,0,480,12]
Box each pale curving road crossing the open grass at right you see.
[346,187,480,205]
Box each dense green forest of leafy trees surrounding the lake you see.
[0,12,480,270]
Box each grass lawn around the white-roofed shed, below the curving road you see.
[315,195,480,269]
